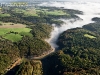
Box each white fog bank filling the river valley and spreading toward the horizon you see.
[44,2,100,48]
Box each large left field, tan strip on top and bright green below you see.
[0,23,32,42]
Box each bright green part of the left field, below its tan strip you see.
[0,28,32,42]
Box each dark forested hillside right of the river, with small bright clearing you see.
[42,18,100,75]
